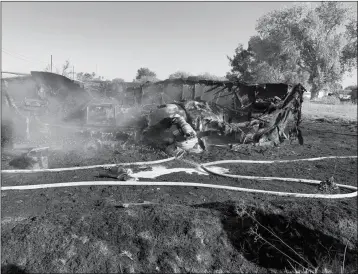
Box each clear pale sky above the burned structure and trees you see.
[1,2,356,85]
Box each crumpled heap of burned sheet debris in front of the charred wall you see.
[142,85,305,154]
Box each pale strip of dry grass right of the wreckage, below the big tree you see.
[302,101,357,121]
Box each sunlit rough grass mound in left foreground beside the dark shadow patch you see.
[1,203,262,273]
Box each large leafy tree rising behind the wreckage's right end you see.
[227,2,357,97]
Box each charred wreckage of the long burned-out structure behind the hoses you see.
[2,72,306,163]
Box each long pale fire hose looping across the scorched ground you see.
[1,156,358,199]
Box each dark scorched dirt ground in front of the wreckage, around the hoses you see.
[1,116,358,273]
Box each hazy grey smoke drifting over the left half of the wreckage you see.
[2,76,162,162]
